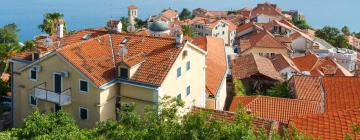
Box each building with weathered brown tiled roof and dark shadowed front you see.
[231,54,283,95]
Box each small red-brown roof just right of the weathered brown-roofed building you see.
[271,54,300,72]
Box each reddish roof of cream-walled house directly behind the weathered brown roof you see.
[240,30,290,52]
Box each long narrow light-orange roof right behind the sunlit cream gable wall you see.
[193,36,227,96]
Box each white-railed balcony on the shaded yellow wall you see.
[34,83,71,106]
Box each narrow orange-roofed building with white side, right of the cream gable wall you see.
[192,36,228,110]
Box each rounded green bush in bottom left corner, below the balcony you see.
[11,109,86,139]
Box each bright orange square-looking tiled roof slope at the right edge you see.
[323,77,360,112]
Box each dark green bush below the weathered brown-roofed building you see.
[266,82,291,98]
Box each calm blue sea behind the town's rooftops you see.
[0,0,360,41]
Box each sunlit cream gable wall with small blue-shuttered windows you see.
[160,42,205,111]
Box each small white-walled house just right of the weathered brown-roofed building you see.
[271,54,301,80]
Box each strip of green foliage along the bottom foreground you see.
[0,97,310,140]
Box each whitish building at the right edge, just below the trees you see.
[328,48,358,73]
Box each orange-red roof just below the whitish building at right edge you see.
[292,53,352,76]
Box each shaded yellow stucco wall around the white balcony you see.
[14,55,100,127]
